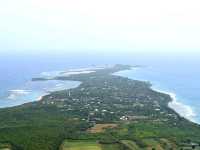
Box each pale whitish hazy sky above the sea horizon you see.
[0,0,200,54]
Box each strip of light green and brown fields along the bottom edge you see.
[60,138,177,150]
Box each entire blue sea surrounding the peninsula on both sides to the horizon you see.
[0,54,200,123]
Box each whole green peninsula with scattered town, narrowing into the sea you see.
[0,65,200,150]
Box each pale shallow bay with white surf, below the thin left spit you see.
[0,77,80,108]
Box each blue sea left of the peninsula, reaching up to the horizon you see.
[0,51,120,108]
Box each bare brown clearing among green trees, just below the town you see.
[88,124,118,133]
